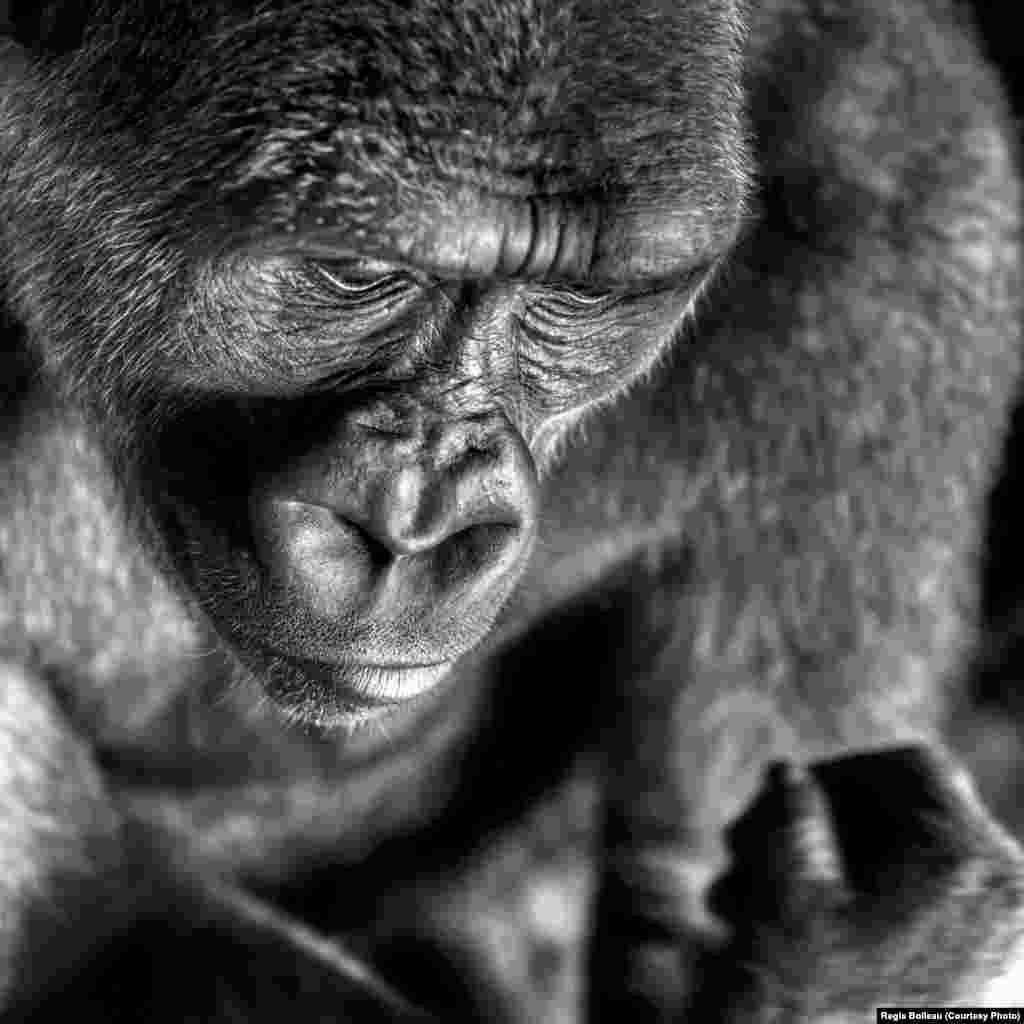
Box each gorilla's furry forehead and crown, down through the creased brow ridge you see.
[24,0,749,285]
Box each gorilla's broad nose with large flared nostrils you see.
[250,407,538,657]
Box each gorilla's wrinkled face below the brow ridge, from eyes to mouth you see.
[145,251,716,724]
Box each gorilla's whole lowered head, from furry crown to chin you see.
[6,4,746,720]
